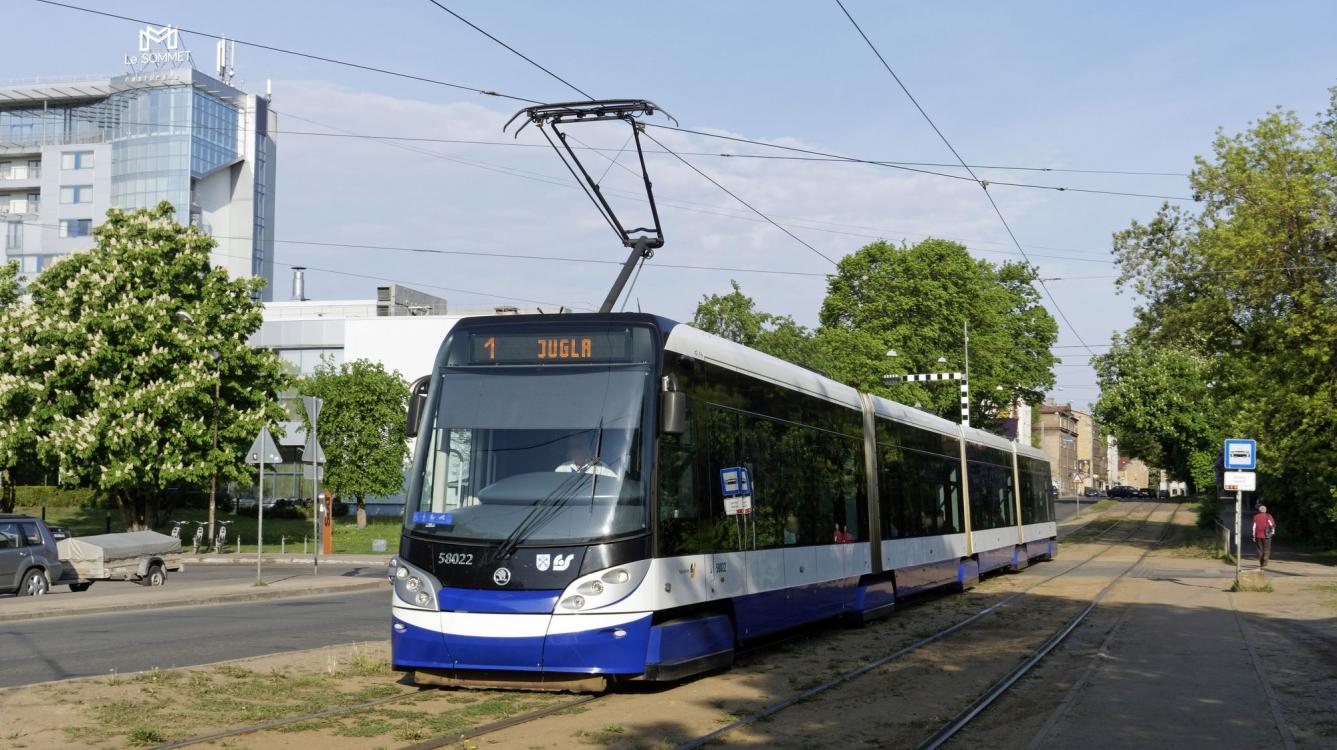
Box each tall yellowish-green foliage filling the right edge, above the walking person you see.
[1114,88,1337,541]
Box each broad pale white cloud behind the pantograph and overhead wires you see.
[274,82,1104,325]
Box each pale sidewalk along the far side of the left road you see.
[0,556,389,622]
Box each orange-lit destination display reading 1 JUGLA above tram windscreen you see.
[469,329,631,365]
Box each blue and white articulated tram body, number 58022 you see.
[390,314,1056,690]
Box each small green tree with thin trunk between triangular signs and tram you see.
[299,360,409,528]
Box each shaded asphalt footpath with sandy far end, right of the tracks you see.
[1038,513,1337,750]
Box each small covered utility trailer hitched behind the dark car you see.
[52,531,185,591]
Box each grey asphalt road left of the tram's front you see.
[0,588,390,687]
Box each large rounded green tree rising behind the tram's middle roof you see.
[816,239,1058,425]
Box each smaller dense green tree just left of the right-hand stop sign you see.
[1091,334,1223,493]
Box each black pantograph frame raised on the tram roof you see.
[501,99,678,313]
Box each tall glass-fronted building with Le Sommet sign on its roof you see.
[0,67,277,299]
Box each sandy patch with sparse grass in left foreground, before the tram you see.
[0,643,562,750]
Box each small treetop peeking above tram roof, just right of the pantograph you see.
[691,279,816,365]
